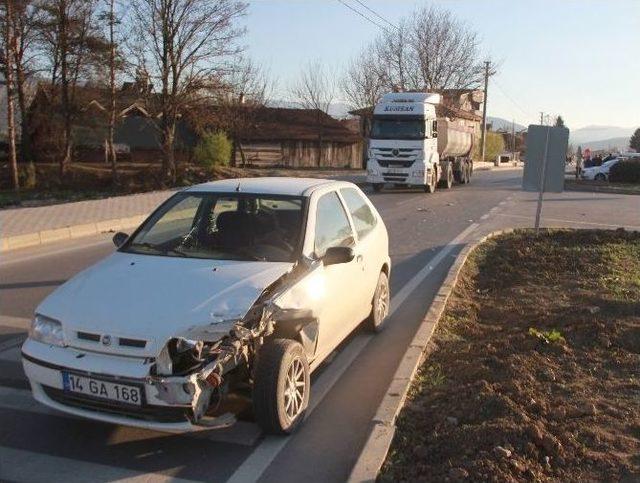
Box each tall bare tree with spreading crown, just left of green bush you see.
[133,0,247,184]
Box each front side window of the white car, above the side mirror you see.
[314,191,353,257]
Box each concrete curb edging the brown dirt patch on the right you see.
[348,228,514,483]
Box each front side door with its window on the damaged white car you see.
[313,190,362,358]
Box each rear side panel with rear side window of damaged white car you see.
[340,187,384,322]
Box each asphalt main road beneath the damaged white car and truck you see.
[0,170,521,482]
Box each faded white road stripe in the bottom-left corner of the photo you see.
[0,446,199,483]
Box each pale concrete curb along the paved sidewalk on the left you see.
[0,213,149,253]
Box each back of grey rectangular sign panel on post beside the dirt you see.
[522,124,569,193]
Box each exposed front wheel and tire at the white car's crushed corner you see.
[253,339,311,434]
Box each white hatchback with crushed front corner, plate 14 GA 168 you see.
[22,178,391,433]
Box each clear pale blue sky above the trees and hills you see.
[245,0,640,129]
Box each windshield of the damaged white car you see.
[120,192,303,262]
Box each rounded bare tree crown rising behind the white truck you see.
[342,7,482,107]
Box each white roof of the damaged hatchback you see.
[186,176,347,196]
